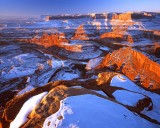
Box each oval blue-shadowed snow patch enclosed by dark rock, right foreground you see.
[113,90,145,106]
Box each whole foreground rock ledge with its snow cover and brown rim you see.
[2,72,160,128]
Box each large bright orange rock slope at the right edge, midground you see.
[97,47,160,90]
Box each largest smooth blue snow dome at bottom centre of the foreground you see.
[43,94,159,128]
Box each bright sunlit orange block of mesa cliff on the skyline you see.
[111,12,132,21]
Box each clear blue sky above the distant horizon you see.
[0,0,160,16]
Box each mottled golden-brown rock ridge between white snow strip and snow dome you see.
[23,85,104,128]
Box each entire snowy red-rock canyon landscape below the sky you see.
[0,12,160,128]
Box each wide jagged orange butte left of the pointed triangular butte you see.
[28,33,68,48]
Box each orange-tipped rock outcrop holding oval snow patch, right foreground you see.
[96,72,153,112]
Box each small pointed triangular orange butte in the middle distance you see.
[71,24,89,40]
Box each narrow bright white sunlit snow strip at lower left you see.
[10,92,48,128]
